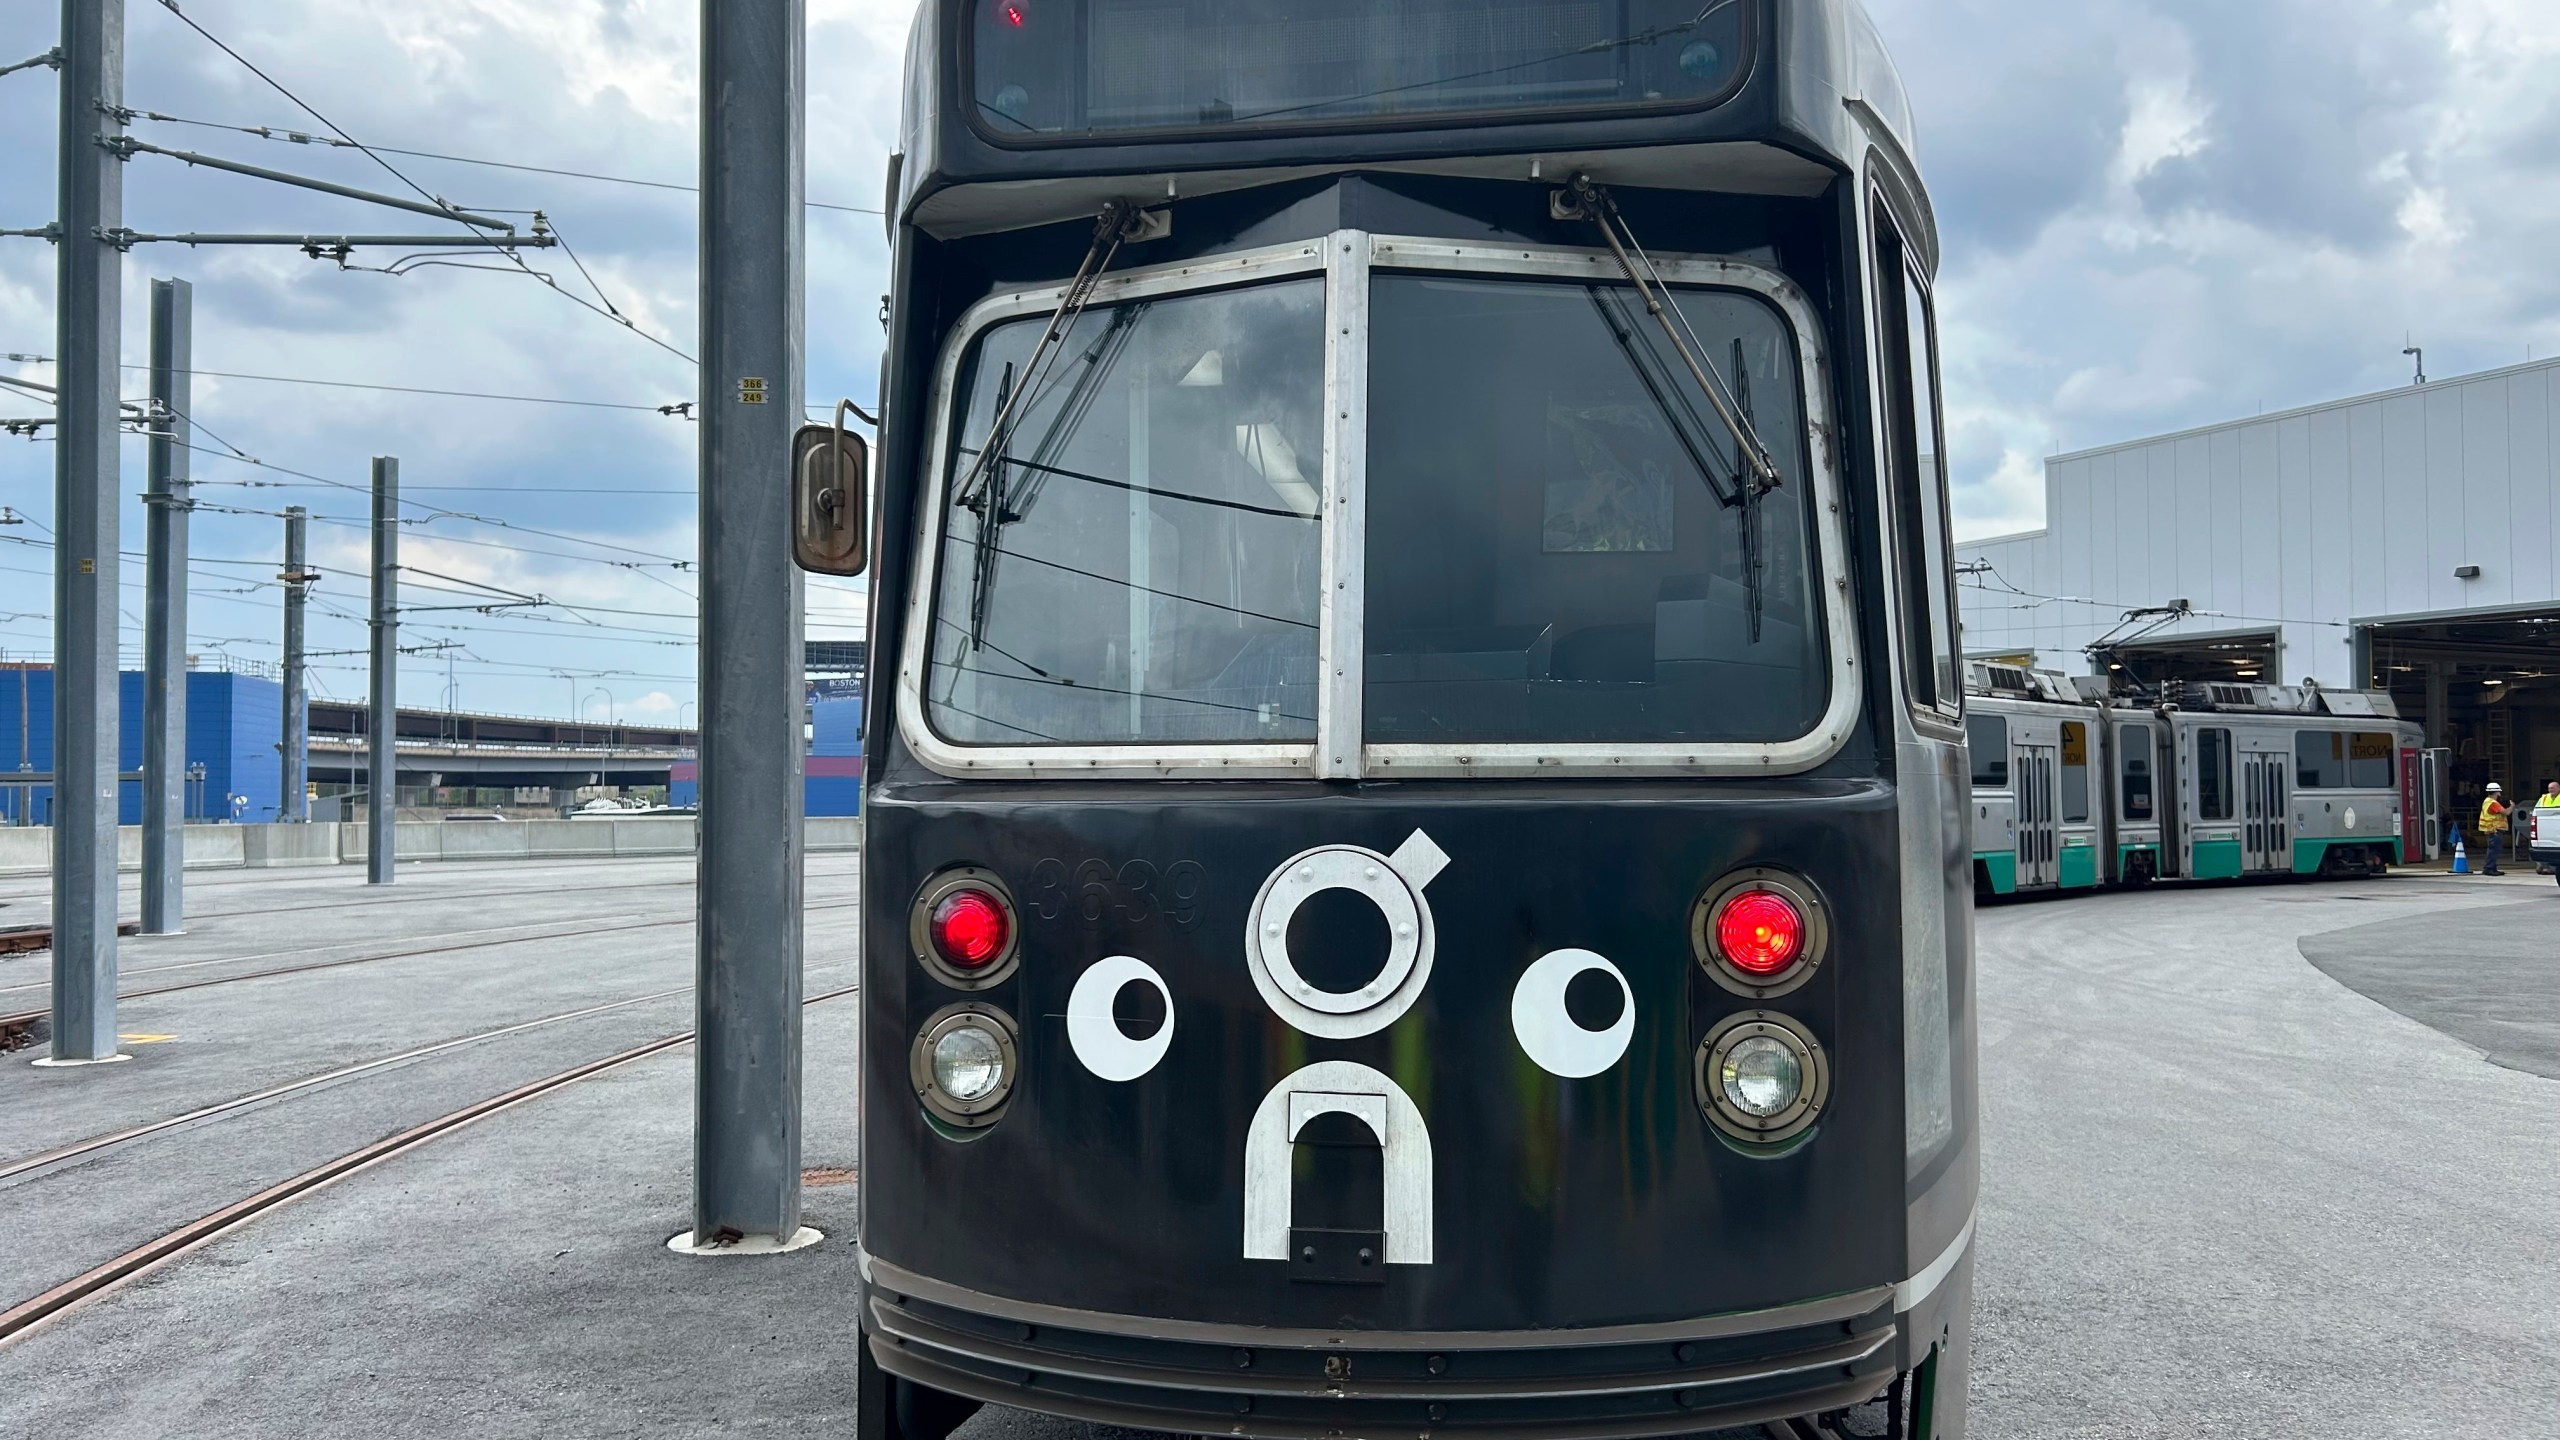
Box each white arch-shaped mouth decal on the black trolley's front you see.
[1244,1061,1431,1266]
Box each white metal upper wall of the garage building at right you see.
[1958,351,2560,684]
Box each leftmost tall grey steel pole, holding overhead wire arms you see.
[51,0,125,1063]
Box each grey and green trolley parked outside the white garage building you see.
[1966,661,2440,894]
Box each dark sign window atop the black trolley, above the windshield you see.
[970,0,1756,143]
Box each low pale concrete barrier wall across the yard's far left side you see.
[0,815,863,876]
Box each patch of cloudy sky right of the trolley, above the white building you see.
[1874,0,2560,536]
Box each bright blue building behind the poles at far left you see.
[0,666,284,825]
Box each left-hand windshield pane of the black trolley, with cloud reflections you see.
[924,279,1324,746]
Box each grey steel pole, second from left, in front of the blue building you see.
[143,279,195,935]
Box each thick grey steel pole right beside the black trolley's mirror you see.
[678,0,806,1248]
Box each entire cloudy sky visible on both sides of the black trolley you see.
[0,0,2560,720]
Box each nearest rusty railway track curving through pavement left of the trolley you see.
[0,984,860,1345]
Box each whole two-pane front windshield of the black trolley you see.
[922,272,1830,748]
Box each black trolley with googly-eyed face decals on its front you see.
[796,0,1976,1440]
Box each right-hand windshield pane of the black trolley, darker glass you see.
[1364,274,1830,746]
